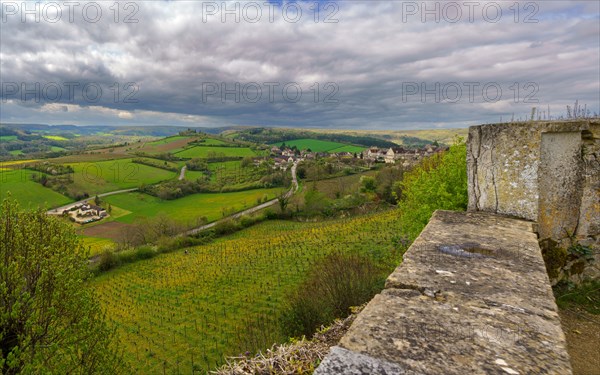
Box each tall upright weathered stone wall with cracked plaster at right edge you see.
[467,119,600,283]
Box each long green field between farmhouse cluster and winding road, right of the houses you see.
[103,188,281,225]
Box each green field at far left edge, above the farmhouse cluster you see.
[0,169,72,208]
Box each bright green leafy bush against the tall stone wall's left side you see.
[398,138,468,242]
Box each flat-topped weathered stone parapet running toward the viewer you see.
[315,211,571,375]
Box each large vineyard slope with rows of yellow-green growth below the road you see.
[92,211,399,374]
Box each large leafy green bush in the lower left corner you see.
[0,200,124,374]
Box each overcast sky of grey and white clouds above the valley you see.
[0,0,600,129]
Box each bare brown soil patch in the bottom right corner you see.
[559,308,600,375]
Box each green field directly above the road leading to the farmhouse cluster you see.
[68,159,178,195]
